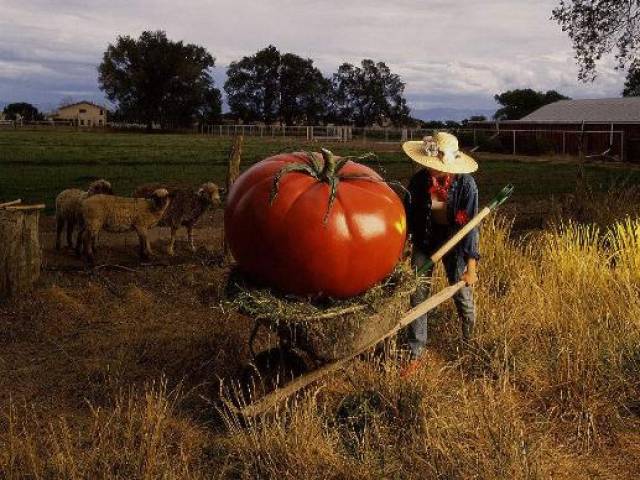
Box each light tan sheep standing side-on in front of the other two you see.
[82,188,171,264]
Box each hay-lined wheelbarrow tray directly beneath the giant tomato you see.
[227,262,424,361]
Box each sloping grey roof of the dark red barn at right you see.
[519,97,640,123]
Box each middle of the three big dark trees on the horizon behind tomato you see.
[224,45,330,124]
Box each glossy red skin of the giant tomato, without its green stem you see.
[224,153,406,298]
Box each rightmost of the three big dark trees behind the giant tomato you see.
[333,59,410,127]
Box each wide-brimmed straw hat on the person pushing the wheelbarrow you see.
[402,132,478,174]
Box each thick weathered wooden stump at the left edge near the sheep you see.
[0,202,44,298]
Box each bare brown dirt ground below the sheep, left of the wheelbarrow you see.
[0,210,271,424]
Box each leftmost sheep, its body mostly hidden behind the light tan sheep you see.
[56,179,113,250]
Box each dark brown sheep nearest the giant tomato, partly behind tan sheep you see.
[133,182,222,256]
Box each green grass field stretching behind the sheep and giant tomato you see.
[0,130,640,213]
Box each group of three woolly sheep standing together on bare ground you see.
[56,179,221,264]
